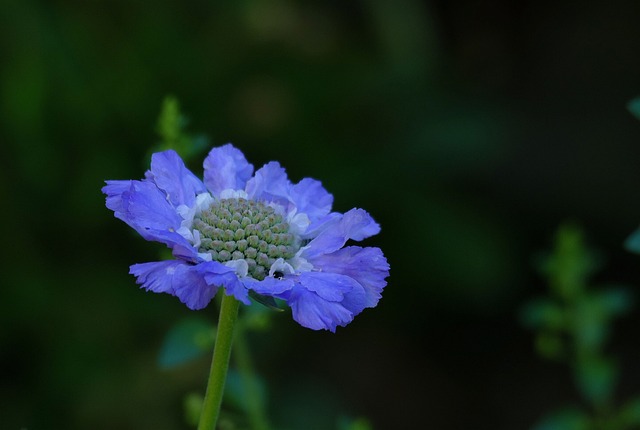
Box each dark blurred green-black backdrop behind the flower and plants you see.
[0,0,640,430]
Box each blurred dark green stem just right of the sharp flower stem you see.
[234,324,269,430]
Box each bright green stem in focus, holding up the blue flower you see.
[198,294,240,430]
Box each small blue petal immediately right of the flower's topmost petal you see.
[247,161,291,208]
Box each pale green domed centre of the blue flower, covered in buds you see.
[193,198,300,280]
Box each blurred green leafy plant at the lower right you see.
[522,225,640,430]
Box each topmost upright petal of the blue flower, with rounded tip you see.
[204,143,253,196]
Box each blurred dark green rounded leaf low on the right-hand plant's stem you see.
[576,358,618,405]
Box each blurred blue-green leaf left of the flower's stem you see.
[158,317,215,369]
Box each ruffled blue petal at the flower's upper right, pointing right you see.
[302,209,380,259]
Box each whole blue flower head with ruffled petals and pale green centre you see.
[102,144,389,331]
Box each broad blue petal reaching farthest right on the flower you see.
[311,246,389,308]
